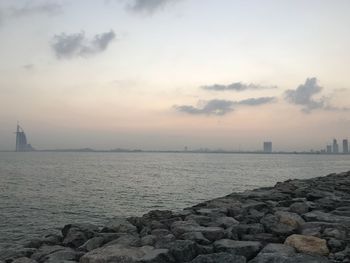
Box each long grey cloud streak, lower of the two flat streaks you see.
[174,97,275,116]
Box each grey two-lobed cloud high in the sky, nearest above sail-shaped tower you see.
[51,30,116,59]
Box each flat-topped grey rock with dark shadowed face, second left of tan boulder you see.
[214,239,262,259]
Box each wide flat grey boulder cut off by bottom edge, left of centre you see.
[80,245,174,263]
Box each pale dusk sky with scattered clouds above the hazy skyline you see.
[0,0,350,151]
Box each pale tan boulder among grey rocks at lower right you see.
[284,234,329,256]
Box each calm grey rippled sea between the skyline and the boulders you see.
[0,152,350,250]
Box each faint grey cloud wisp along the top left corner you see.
[10,2,63,17]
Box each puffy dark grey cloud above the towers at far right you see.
[285,78,327,113]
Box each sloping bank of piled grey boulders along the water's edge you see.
[0,172,350,263]
